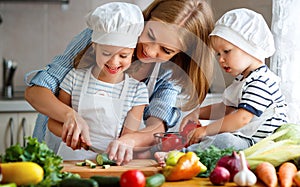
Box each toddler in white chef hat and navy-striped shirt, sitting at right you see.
[181,9,287,150]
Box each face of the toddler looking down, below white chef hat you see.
[212,36,262,77]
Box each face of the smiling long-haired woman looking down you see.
[136,19,181,63]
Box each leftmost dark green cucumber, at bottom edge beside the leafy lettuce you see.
[59,178,98,187]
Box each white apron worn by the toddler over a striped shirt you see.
[223,76,276,138]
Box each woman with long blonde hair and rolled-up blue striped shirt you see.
[25,0,214,164]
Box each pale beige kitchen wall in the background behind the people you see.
[0,0,272,90]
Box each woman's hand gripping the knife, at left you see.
[61,111,91,150]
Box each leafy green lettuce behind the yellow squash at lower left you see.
[1,137,79,187]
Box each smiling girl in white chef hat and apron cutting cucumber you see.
[48,2,148,160]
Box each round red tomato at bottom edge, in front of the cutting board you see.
[120,170,146,187]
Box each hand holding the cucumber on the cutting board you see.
[107,138,134,165]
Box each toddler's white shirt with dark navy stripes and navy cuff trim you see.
[226,65,287,141]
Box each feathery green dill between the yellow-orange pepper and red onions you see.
[195,146,235,177]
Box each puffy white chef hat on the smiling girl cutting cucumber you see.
[86,2,144,48]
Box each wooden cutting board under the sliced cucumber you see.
[62,159,162,178]
